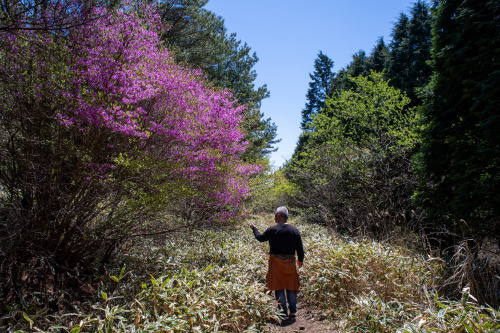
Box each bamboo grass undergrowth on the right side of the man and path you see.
[298,219,500,333]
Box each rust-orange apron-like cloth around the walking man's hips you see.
[267,254,300,291]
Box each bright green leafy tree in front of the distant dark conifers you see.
[285,72,417,234]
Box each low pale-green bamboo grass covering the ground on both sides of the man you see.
[0,215,500,333]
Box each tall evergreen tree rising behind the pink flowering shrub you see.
[159,0,279,161]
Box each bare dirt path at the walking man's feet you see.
[267,299,341,333]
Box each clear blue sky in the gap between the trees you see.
[205,0,414,167]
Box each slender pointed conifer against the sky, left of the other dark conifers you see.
[300,51,335,130]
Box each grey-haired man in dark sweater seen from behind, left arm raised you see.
[249,206,304,320]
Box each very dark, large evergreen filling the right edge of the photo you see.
[416,0,500,235]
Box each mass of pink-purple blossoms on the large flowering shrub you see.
[2,6,262,221]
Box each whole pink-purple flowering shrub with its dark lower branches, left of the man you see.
[0,2,259,276]
